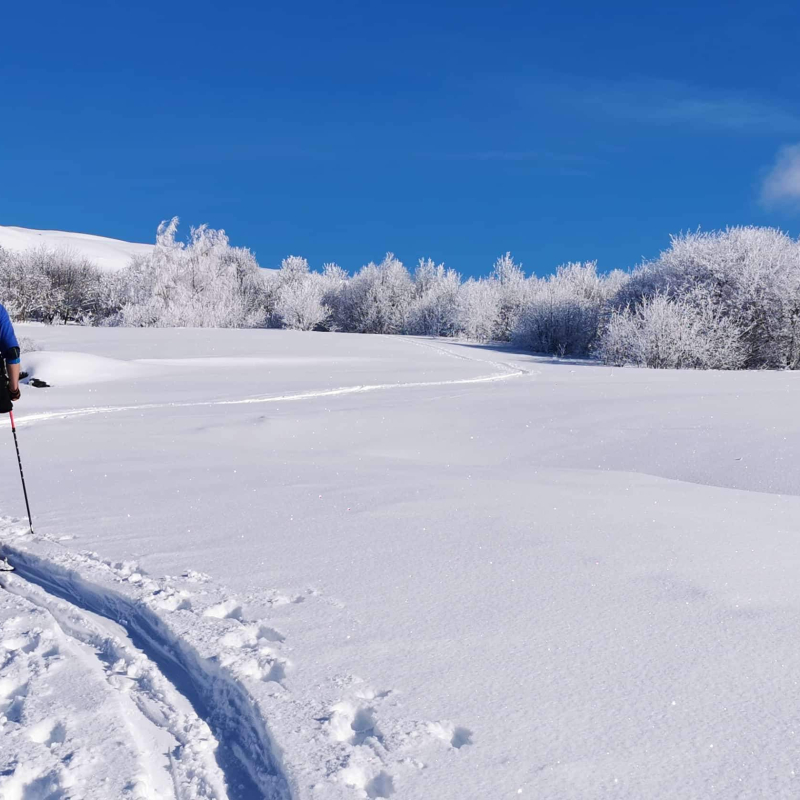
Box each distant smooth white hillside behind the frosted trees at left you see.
[0,225,153,270]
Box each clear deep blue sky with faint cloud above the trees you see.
[0,0,800,275]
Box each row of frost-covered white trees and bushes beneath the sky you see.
[0,218,800,369]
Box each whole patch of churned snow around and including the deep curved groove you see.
[0,518,472,800]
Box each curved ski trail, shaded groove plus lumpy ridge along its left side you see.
[0,545,290,800]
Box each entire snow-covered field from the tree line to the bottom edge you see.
[0,326,800,800]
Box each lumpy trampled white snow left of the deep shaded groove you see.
[0,573,228,800]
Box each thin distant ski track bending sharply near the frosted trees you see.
[16,339,534,432]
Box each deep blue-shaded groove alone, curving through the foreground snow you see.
[4,545,291,800]
